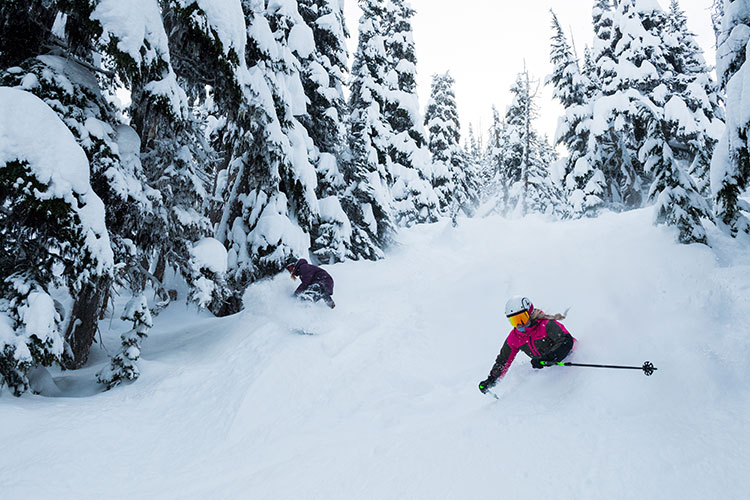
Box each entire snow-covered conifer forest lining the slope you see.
[0,0,750,395]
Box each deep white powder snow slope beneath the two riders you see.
[0,210,750,500]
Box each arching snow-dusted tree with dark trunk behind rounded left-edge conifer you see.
[0,55,158,368]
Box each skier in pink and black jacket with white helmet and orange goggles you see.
[479,296,576,394]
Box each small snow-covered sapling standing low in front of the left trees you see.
[96,294,154,390]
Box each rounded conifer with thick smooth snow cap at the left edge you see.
[0,87,114,395]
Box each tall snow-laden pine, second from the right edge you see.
[620,1,713,243]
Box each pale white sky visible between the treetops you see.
[345,0,715,147]
